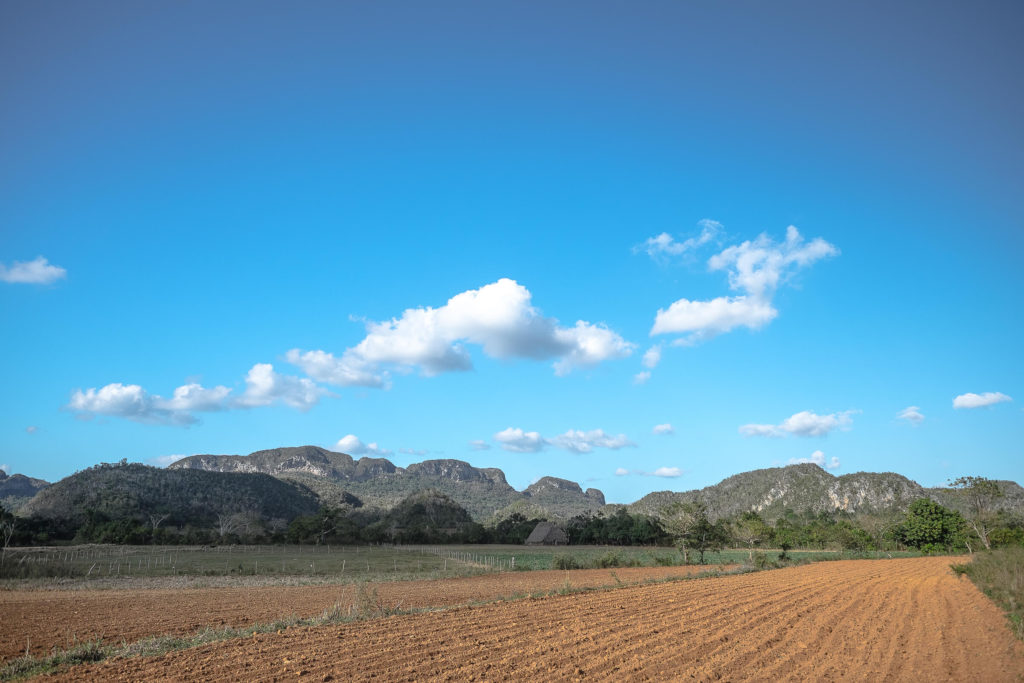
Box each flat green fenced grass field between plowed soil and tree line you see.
[0,545,925,584]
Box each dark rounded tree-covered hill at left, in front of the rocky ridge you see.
[20,463,319,526]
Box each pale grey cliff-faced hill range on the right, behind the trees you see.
[627,464,1024,519]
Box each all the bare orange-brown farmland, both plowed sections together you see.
[0,551,1024,681]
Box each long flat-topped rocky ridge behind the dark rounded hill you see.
[170,445,604,521]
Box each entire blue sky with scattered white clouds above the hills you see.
[0,1,1024,502]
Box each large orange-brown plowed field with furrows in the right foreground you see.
[51,558,1024,681]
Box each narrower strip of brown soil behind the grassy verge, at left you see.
[0,567,710,660]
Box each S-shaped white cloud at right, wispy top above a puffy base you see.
[650,225,839,345]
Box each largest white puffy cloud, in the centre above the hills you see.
[286,279,635,386]
